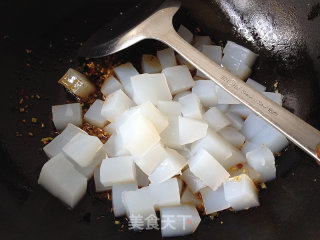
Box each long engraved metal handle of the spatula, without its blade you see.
[158,27,320,163]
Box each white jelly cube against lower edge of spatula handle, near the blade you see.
[162,65,194,95]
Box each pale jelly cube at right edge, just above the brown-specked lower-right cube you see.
[246,145,276,182]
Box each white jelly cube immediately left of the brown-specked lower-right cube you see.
[200,185,230,214]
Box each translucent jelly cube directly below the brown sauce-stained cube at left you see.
[52,103,82,131]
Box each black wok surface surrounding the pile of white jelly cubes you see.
[0,0,320,240]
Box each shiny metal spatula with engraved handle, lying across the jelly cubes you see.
[80,0,320,163]
